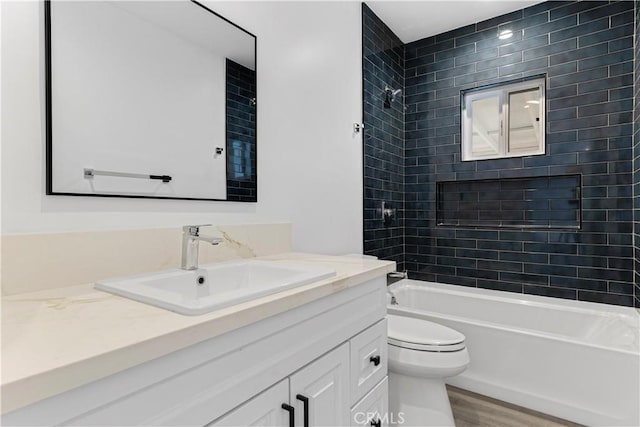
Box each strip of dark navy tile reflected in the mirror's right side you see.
[222,58,257,202]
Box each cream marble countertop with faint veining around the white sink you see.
[0,253,395,413]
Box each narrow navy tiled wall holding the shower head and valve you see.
[362,5,405,270]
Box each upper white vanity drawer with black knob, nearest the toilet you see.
[349,319,387,405]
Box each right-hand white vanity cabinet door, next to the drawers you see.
[290,343,351,427]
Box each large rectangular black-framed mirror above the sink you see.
[44,0,257,202]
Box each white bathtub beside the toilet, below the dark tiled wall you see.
[388,280,640,427]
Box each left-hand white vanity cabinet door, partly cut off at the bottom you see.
[207,379,289,427]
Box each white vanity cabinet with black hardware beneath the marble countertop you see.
[2,276,387,427]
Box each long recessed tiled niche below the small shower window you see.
[436,175,582,230]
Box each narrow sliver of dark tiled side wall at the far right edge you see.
[633,1,640,308]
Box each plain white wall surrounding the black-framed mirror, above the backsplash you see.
[1,1,362,254]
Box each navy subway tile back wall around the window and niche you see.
[365,1,634,305]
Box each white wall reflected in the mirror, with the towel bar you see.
[51,1,228,199]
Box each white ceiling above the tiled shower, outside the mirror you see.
[366,0,541,43]
